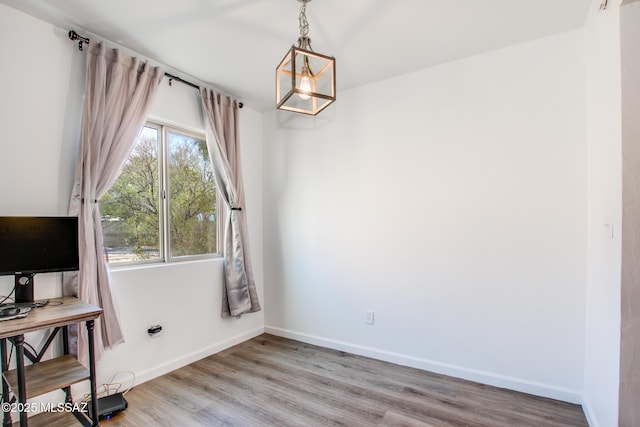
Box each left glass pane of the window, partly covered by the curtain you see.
[100,126,160,265]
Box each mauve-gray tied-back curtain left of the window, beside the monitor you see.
[64,42,164,362]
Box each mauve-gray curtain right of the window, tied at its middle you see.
[200,88,260,317]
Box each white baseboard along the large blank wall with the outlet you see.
[264,326,583,404]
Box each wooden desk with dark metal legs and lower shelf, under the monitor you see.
[0,297,102,426]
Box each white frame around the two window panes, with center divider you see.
[105,118,222,270]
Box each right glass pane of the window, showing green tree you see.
[167,131,217,257]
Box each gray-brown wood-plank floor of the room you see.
[46,334,587,427]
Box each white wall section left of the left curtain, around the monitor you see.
[0,5,84,298]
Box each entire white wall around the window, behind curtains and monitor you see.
[0,5,264,402]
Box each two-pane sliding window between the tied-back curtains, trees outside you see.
[100,123,218,265]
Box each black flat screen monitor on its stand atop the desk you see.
[0,216,79,302]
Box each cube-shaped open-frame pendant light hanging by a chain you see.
[276,0,336,116]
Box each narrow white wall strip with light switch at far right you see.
[584,0,622,427]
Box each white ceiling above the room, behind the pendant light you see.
[0,0,591,111]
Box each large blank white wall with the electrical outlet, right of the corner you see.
[264,31,587,402]
